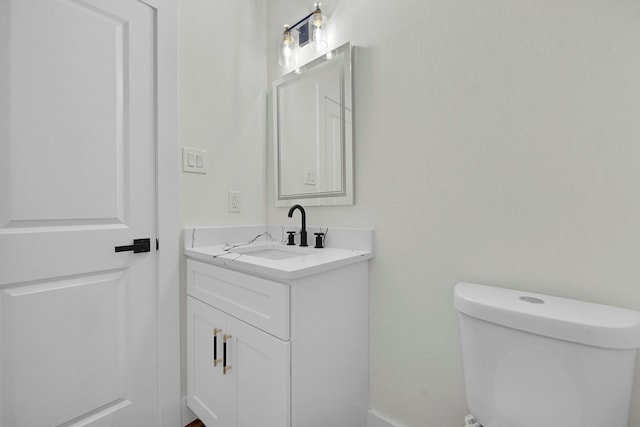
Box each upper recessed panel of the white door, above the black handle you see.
[11,0,127,225]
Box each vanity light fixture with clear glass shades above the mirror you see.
[279,2,328,68]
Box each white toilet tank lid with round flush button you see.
[454,283,640,349]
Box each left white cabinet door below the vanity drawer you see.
[187,297,234,427]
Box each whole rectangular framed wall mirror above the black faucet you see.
[273,43,354,206]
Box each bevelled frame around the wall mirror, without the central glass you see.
[272,43,354,207]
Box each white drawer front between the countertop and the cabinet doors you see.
[187,259,289,340]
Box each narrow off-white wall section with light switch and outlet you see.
[178,0,267,402]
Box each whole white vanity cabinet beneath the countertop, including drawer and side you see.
[187,259,368,427]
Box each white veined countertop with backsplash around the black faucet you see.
[184,226,374,280]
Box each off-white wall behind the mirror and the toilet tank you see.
[266,0,640,427]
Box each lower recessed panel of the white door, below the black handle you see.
[1,271,130,425]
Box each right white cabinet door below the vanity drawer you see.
[228,317,291,427]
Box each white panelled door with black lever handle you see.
[0,0,159,427]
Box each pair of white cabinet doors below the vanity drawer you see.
[187,297,290,427]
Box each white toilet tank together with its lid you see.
[454,283,640,427]
